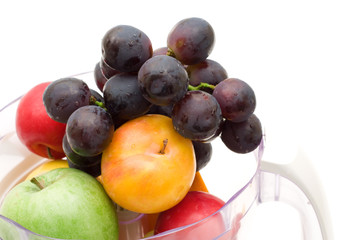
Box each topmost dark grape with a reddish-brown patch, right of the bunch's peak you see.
[167,18,215,65]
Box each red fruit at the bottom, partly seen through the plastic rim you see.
[154,191,225,240]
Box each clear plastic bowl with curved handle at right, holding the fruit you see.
[0,72,331,240]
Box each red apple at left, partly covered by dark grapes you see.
[16,82,66,159]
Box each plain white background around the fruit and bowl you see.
[0,0,361,239]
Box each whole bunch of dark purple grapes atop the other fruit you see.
[43,17,262,176]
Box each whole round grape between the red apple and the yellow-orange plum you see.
[66,105,114,157]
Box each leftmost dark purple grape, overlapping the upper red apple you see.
[43,77,91,123]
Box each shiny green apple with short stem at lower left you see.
[0,168,118,240]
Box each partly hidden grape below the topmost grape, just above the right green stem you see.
[187,59,228,93]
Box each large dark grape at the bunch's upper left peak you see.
[102,25,153,72]
